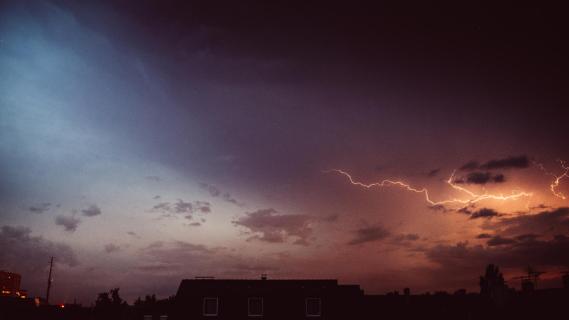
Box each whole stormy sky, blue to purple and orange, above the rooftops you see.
[0,1,569,304]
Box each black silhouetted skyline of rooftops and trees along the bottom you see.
[0,265,569,320]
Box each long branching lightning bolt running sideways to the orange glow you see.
[324,169,533,206]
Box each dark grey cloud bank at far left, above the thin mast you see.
[0,225,78,272]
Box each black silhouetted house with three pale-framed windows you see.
[170,278,363,320]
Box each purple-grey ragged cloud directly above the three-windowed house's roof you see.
[233,208,312,245]
